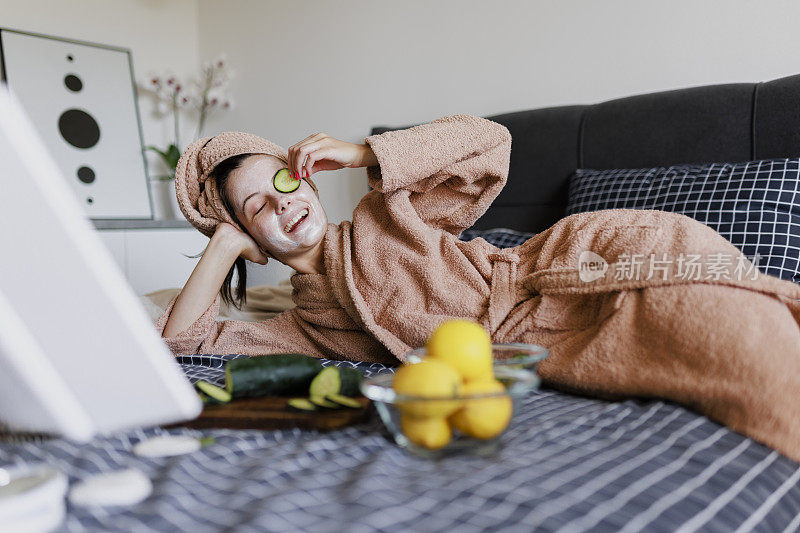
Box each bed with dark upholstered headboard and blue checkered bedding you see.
[0,76,800,532]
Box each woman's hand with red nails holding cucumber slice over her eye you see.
[288,133,378,179]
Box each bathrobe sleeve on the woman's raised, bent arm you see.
[365,114,511,236]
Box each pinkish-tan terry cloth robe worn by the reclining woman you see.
[156,115,800,461]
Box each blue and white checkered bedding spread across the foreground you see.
[0,355,800,532]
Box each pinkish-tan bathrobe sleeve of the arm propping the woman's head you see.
[155,294,397,364]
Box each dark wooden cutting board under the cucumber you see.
[171,396,375,431]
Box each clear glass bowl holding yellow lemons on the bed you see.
[361,343,549,458]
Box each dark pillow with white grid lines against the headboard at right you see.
[567,159,800,283]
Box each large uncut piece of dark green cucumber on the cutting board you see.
[225,353,322,398]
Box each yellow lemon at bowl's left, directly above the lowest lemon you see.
[392,359,461,418]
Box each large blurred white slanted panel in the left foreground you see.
[0,83,202,440]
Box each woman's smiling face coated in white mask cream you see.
[226,154,328,260]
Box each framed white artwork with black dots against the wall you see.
[0,28,153,219]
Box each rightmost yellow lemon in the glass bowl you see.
[448,378,512,439]
